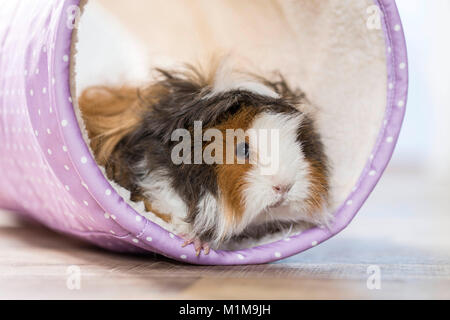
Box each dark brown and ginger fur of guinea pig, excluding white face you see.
[78,64,329,250]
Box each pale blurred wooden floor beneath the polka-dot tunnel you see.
[0,165,450,299]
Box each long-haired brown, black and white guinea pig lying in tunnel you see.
[79,63,331,255]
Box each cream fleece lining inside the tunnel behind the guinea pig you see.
[73,0,387,249]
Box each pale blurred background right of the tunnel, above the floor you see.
[392,0,450,178]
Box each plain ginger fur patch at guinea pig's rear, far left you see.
[78,87,141,165]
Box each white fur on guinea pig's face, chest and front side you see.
[139,94,332,246]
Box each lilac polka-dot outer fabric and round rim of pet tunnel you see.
[0,0,408,265]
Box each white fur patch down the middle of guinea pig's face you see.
[243,113,326,230]
